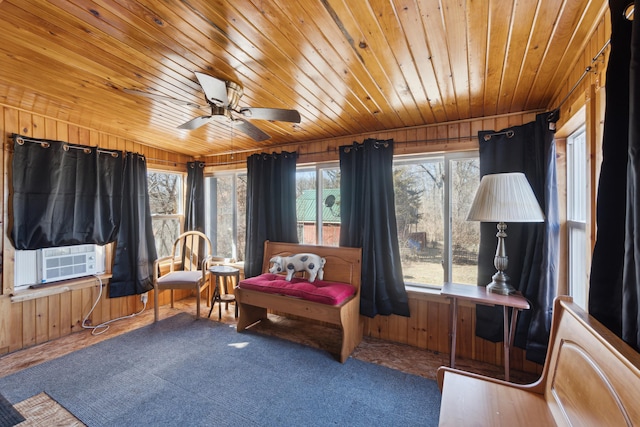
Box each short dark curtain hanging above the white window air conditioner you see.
[11,134,123,250]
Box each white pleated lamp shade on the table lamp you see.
[467,172,544,222]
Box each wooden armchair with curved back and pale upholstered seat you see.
[153,231,213,321]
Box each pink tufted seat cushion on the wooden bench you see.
[238,273,356,305]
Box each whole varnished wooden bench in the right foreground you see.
[438,297,640,427]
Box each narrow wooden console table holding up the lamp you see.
[440,283,530,381]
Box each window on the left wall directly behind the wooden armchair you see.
[147,171,184,257]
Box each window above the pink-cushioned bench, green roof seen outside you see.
[296,165,340,246]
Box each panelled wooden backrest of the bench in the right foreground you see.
[541,297,640,426]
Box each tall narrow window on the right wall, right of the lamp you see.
[567,128,588,309]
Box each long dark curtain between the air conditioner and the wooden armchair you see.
[109,153,158,298]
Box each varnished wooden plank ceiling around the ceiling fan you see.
[0,0,606,156]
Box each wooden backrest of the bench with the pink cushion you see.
[262,240,362,292]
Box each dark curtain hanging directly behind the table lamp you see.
[476,113,560,363]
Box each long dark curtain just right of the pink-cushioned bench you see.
[340,139,409,317]
